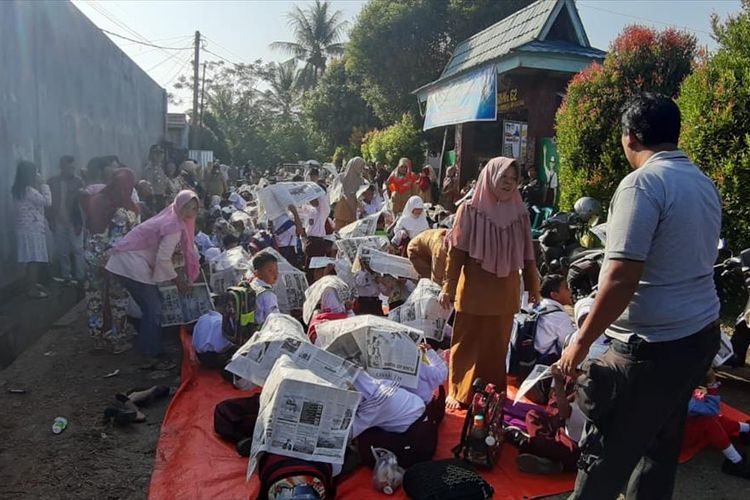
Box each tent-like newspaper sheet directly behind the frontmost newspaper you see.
[226,313,360,388]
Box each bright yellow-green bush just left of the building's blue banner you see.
[362,114,424,167]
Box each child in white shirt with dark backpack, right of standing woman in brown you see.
[534,274,576,365]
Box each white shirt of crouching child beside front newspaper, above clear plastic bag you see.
[352,371,425,437]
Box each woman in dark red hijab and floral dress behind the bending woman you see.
[81,168,139,354]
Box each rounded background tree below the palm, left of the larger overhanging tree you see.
[303,61,379,158]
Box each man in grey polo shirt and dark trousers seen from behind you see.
[559,93,728,500]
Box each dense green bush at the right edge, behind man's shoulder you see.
[679,0,750,249]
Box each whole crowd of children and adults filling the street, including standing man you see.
[8,94,750,498]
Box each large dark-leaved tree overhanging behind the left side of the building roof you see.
[346,0,533,123]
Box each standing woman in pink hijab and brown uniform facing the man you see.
[440,157,540,409]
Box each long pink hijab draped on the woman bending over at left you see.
[114,189,200,283]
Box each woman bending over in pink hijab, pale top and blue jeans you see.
[107,190,200,360]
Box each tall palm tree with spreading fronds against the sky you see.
[271,0,348,88]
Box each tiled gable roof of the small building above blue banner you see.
[415,0,605,94]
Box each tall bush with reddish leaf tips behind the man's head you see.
[556,26,696,209]
